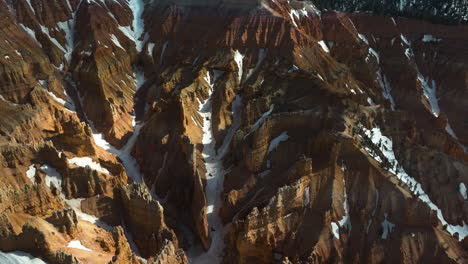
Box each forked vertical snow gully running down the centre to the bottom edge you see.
[191,73,242,263]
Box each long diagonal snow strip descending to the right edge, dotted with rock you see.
[361,126,468,241]
